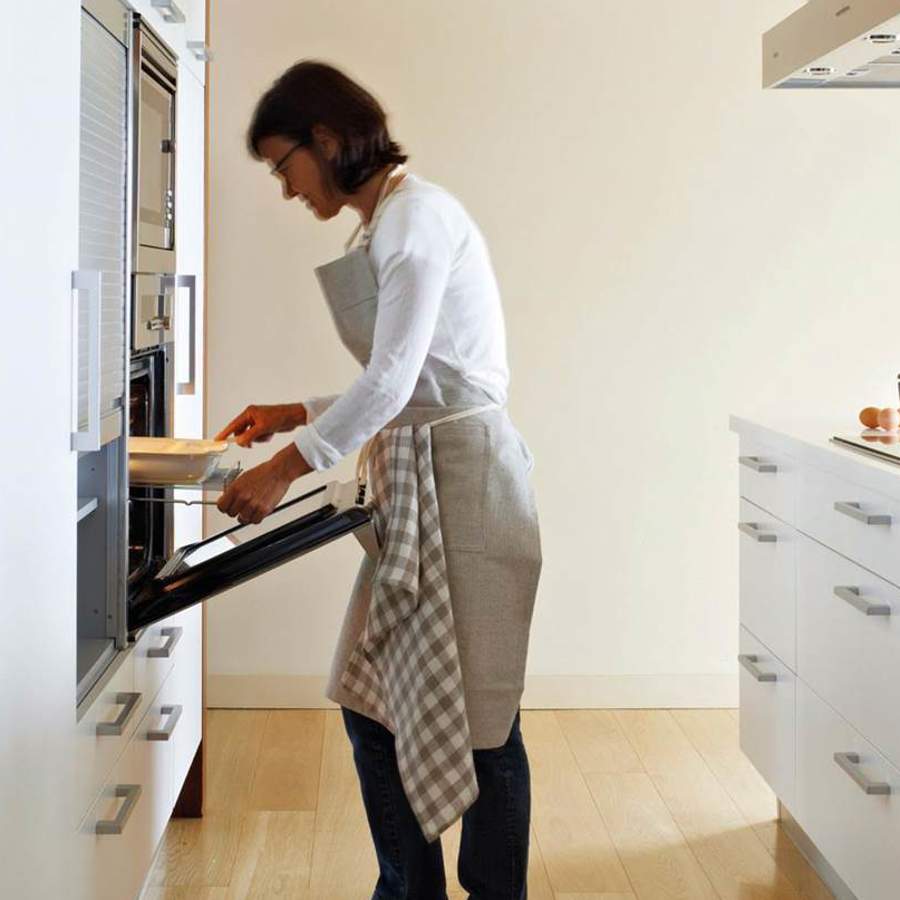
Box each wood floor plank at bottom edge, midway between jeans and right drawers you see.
[586,773,716,900]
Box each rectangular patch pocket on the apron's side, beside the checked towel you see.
[431,422,490,551]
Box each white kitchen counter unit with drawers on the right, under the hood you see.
[730,416,900,900]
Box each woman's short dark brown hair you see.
[247,59,408,194]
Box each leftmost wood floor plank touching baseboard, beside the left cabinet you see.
[203,709,269,815]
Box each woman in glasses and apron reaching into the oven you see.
[217,61,541,900]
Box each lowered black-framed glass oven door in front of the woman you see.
[128,482,378,636]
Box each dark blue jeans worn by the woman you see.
[341,706,531,900]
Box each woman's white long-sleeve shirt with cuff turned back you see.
[294,172,509,470]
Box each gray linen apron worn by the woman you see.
[316,167,542,839]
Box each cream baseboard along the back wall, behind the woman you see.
[206,673,738,709]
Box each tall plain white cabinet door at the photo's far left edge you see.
[0,3,83,900]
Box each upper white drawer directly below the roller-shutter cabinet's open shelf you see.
[70,651,135,828]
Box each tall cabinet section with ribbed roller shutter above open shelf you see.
[73,0,129,701]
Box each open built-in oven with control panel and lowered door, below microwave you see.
[122,284,378,640]
